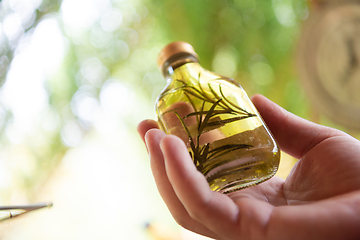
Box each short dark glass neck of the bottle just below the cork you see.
[162,52,199,77]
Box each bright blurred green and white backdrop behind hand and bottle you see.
[0,0,358,240]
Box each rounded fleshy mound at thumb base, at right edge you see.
[284,136,360,204]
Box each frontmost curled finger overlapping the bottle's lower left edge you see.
[160,136,239,239]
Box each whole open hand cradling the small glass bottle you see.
[138,95,360,240]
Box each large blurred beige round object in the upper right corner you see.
[298,0,360,130]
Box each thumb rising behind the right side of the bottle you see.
[251,94,345,158]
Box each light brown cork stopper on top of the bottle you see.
[157,41,198,69]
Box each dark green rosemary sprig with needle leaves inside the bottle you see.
[162,74,256,172]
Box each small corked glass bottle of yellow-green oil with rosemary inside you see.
[156,42,280,193]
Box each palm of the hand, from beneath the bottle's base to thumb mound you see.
[242,136,360,206]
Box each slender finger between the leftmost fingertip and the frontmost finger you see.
[145,129,217,238]
